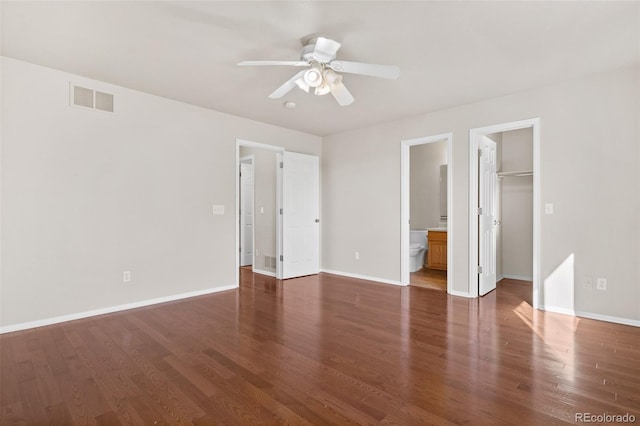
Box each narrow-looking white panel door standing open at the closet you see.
[478,136,498,296]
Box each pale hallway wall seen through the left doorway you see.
[240,146,276,273]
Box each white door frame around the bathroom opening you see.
[400,133,454,294]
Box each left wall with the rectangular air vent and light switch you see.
[0,57,321,328]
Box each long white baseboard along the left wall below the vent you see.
[0,285,238,334]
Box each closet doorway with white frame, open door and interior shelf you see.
[469,119,540,308]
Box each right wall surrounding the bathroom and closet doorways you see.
[322,67,640,320]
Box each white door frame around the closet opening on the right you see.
[469,117,541,309]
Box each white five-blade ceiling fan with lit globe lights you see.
[238,37,400,106]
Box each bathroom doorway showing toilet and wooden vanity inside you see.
[401,133,453,292]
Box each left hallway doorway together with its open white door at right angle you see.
[235,139,320,284]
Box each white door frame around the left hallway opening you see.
[233,139,284,286]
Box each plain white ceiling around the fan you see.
[1,1,640,135]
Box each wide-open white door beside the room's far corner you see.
[282,152,320,279]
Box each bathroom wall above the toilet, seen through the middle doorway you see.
[409,141,447,229]
